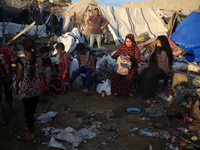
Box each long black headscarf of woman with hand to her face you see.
[157,35,173,66]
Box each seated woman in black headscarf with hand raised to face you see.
[138,36,173,98]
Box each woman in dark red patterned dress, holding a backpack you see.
[111,34,140,97]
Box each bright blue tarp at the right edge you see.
[170,11,200,62]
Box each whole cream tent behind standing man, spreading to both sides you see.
[62,0,167,44]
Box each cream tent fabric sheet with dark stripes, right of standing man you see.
[98,5,167,44]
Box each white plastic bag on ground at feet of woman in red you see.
[96,79,112,95]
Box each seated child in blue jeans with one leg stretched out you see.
[66,43,95,94]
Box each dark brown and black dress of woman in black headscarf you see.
[138,47,170,98]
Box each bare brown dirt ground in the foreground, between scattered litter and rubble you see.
[0,46,192,150]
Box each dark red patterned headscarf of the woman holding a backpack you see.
[115,34,140,62]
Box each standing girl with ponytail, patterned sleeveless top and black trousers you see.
[15,38,45,140]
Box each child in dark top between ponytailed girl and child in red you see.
[40,46,57,91]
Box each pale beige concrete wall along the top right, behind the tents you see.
[121,0,200,10]
